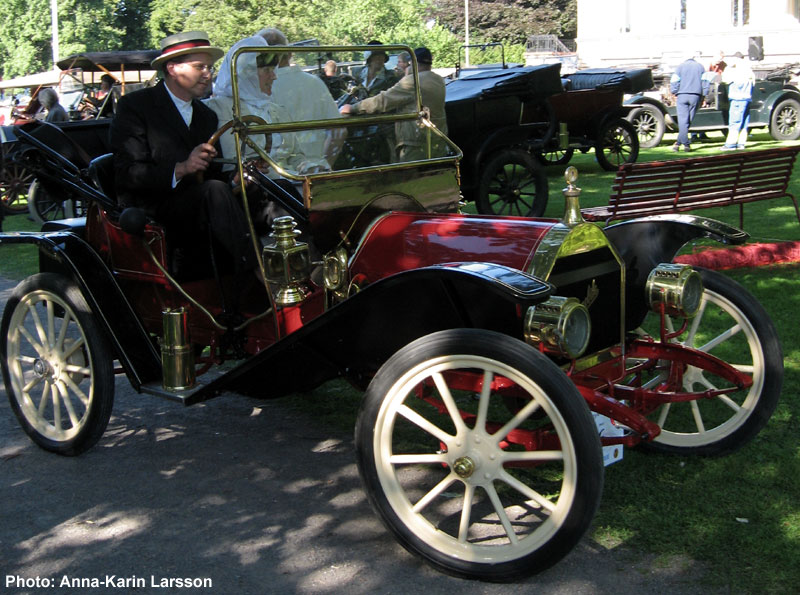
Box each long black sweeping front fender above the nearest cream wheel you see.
[192,263,553,404]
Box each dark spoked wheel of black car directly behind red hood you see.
[475,149,547,217]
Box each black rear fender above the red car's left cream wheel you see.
[0,228,161,390]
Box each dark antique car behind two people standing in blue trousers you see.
[626,68,800,147]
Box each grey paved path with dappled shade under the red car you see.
[0,279,710,595]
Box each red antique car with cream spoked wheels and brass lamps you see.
[0,46,783,581]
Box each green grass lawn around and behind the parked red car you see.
[0,132,800,593]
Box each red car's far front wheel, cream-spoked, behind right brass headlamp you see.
[643,269,783,455]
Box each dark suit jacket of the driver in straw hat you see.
[110,81,220,212]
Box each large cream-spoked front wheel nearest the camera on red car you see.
[356,329,604,581]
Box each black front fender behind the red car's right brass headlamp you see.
[604,215,749,330]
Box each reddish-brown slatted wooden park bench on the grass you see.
[581,146,800,227]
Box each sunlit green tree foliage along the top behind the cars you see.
[0,0,577,78]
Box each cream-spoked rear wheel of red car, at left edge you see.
[0,273,114,456]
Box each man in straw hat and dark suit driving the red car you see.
[110,31,255,273]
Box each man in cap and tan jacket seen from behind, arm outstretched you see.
[339,47,447,161]
